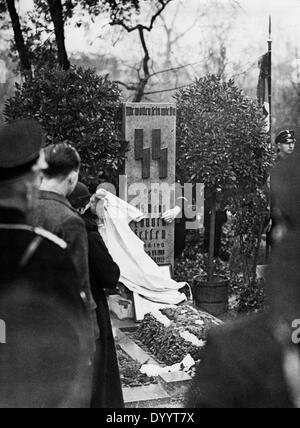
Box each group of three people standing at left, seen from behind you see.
[0,120,123,408]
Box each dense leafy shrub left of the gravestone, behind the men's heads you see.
[5,68,126,187]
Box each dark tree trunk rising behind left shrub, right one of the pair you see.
[48,0,71,70]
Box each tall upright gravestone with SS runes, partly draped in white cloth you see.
[123,103,177,266]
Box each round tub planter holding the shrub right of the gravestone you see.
[193,275,230,317]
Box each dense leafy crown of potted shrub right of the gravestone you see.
[175,75,272,197]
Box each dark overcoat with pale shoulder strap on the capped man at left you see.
[0,208,91,408]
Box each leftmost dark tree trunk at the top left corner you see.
[6,0,32,79]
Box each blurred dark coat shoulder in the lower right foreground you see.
[187,315,293,409]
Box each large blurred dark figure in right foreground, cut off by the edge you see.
[187,156,300,408]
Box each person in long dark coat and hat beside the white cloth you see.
[70,183,124,408]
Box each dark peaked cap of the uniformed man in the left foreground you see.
[0,119,43,181]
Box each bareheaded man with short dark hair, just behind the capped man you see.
[31,143,99,340]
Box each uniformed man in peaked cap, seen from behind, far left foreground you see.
[0,120,91,408]
